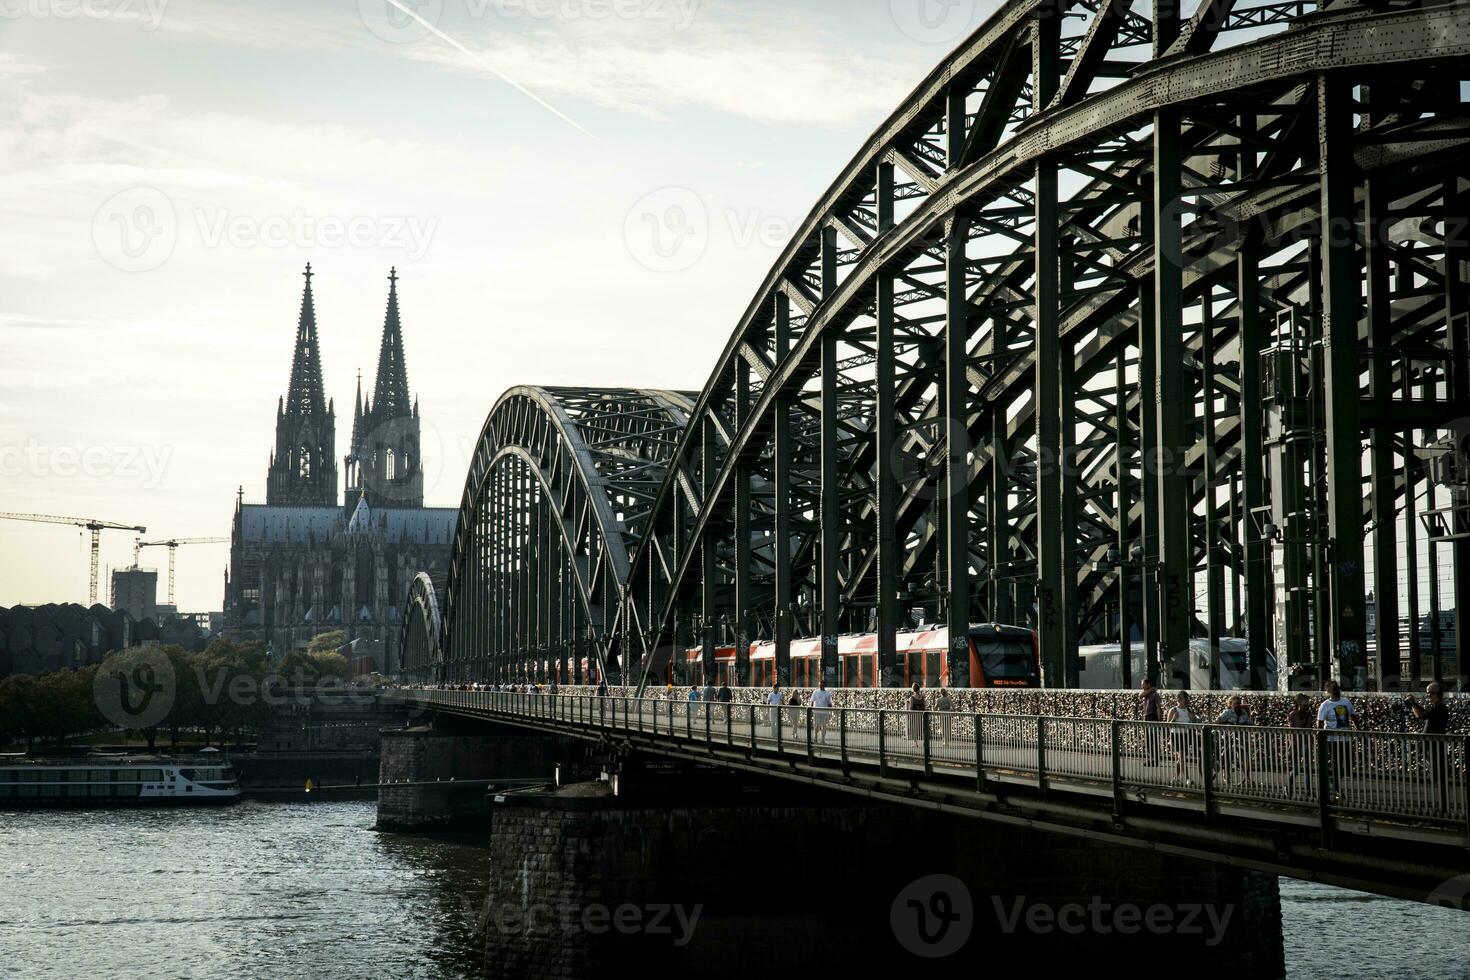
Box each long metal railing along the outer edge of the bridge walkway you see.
[391,691,1470,846]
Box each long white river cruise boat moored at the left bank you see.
[0,752,240,808]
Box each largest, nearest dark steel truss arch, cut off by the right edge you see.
[602,1,1470,693]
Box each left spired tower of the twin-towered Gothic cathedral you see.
[266,263,337,507]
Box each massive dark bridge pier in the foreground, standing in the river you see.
[482,768,1283,980]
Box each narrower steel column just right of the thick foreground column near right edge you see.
[1363,178,1408,691]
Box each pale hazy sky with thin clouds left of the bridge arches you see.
[0,0,995,610]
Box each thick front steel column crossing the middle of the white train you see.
[1152,105,1194,688]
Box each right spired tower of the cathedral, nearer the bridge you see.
[344,269,423,510]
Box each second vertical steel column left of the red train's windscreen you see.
[873,162,903,688]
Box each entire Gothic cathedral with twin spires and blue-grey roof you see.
[223,266,459,673]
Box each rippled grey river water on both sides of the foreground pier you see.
[0,801,1470,980]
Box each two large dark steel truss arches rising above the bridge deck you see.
[423,0,1470,688]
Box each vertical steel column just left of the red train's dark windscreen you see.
[944,215,970,688]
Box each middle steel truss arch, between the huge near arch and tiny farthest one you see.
[432,386,692,680]
